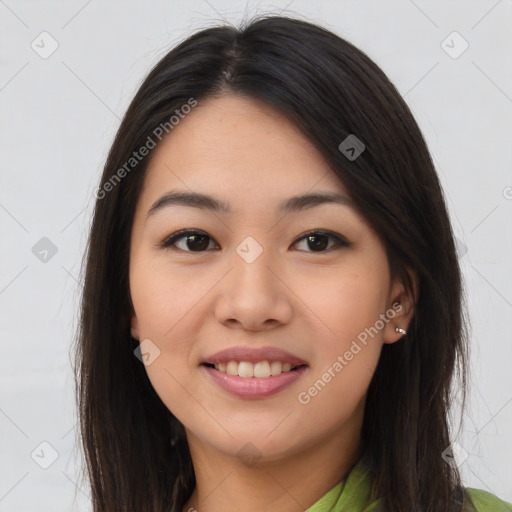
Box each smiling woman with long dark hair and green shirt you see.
[77,16,512,512]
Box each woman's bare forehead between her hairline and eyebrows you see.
[138,95,347,209]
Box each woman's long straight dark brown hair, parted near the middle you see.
[75,16,467,512]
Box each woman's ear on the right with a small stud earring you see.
[383,267,419,343]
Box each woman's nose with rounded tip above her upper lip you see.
[215,244,293,331]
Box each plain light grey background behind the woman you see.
[0,0,512,512]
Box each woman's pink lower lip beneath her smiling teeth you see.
[202,366,308,398]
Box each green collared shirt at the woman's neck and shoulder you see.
[306,459,512,512]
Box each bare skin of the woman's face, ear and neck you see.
[130,95,417,512]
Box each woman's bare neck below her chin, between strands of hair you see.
[182,418,361,512]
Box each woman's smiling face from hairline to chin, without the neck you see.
[130,95,407,460]
